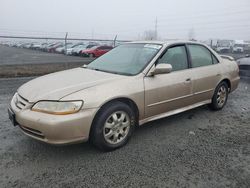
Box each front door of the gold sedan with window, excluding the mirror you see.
[144,45,193,118]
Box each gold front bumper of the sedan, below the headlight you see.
[11,100,98,145]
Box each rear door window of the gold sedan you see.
[188,44,213,67]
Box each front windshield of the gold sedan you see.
[87,44,162,75]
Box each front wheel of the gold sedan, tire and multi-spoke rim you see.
[90,102,136,151]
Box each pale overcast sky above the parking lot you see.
[0,0,250,40]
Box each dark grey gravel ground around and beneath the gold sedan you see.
[0,78,250,188]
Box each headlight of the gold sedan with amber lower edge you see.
[31,101,83,115]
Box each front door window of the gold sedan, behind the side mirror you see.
[158,46,188,71]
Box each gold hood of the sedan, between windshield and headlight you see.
[17,68,126,103]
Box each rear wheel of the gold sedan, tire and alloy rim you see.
[209,82,228,110]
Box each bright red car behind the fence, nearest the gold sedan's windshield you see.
[80,46,113,57]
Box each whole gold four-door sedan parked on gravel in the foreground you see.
[8,41,239,150]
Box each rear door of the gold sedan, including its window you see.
[187,44,221,102]
